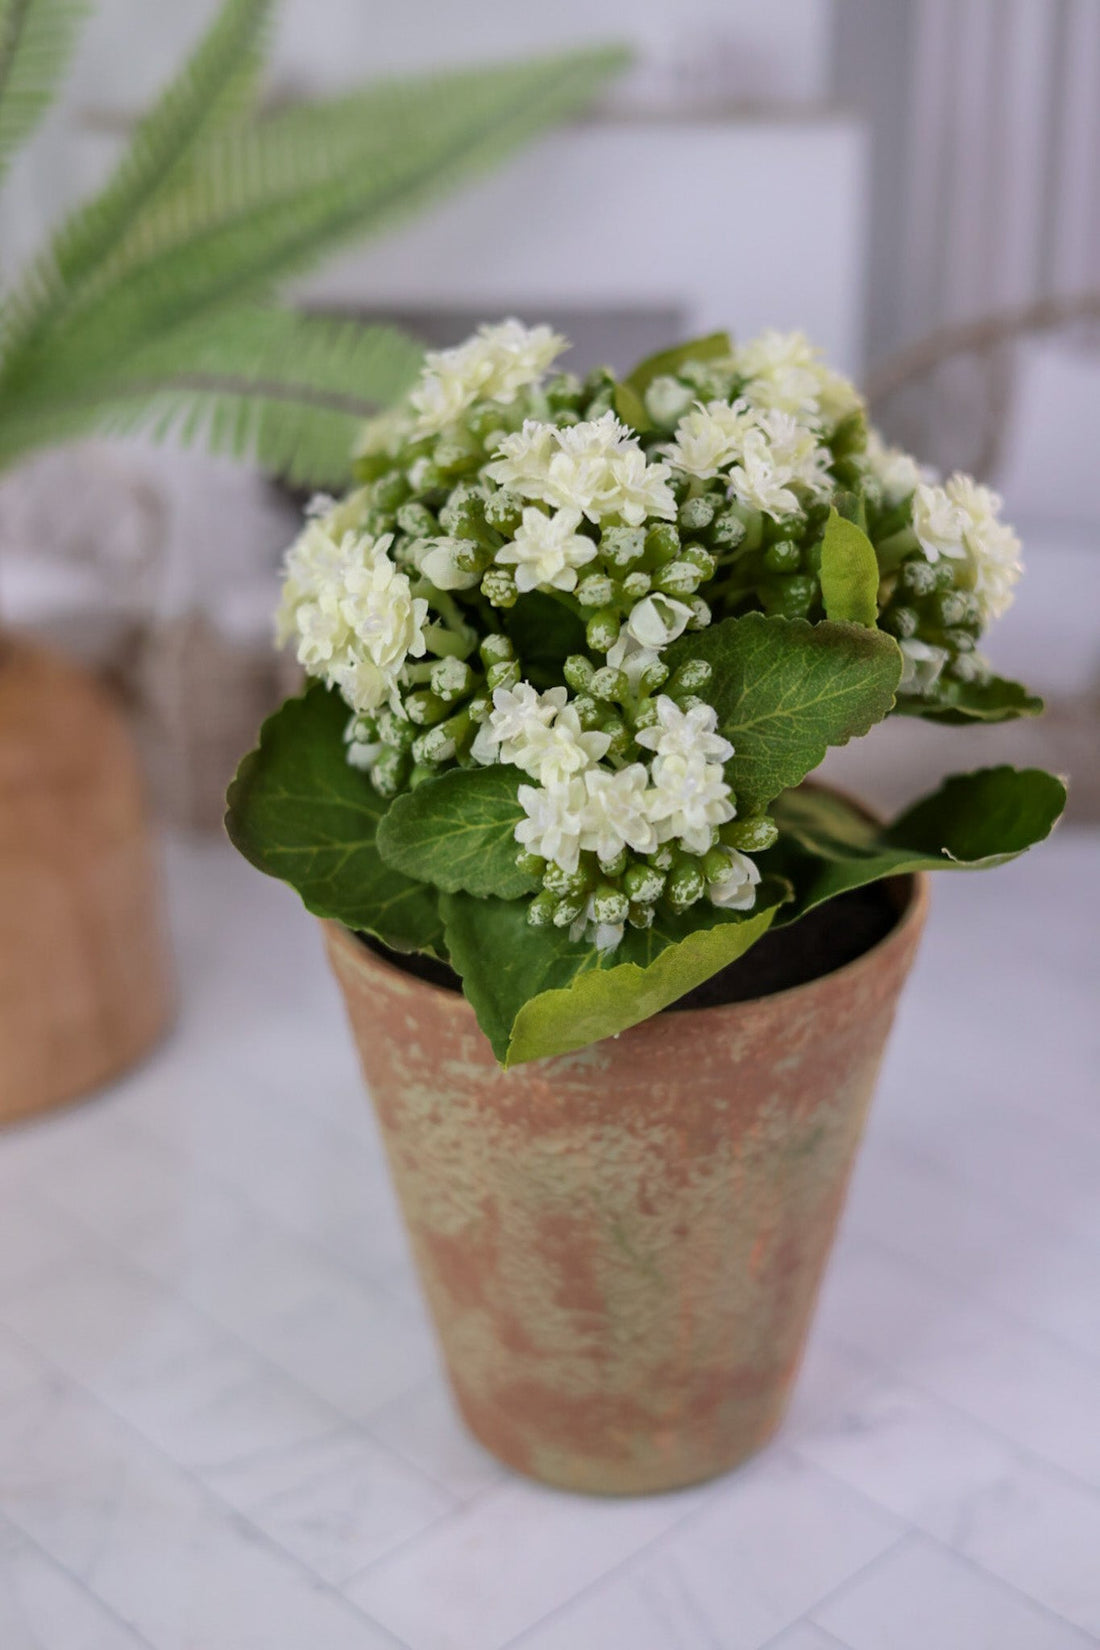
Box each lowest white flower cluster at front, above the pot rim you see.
[473,681,760,949]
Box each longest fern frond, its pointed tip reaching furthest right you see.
[7,51,623,388]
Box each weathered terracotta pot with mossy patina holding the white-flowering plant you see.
[325,878,927,1495]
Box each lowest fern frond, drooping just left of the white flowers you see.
[0,307,422,488]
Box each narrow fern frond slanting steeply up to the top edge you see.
[5,0,272,355]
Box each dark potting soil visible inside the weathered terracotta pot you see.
[358,883,900,1013]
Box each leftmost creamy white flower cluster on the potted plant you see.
[275,520,427,713]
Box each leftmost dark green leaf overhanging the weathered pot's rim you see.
[226,683,444,954]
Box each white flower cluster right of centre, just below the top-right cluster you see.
[665,398,834,520]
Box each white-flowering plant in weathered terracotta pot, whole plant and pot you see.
[228,322,1065,1492]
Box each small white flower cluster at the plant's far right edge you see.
[912,474,1024,622]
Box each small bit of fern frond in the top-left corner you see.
[0,0,87,178]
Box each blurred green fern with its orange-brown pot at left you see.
[0,0,623,1120]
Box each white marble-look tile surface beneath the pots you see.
[0,833,1100,1650]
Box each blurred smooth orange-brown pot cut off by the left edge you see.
[0,635,172,1122]
